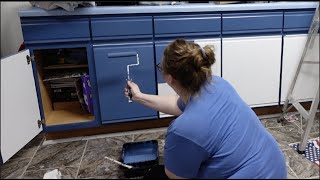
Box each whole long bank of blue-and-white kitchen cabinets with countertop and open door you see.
[1,3,319,165]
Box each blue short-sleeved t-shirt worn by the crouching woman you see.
[164,76,287,179]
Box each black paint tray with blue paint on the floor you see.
[121,140,159,178]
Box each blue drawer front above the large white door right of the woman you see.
[222,12,283,34]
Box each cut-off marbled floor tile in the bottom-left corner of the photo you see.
[0,158,31,179]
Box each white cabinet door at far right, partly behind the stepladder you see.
[280,34,319,104]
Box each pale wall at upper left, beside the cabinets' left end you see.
[1,1,31,57]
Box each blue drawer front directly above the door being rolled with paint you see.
[91,16,153,40]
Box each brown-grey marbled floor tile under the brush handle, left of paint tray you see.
[77,147,122,178]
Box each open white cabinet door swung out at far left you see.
[0,50,42,163]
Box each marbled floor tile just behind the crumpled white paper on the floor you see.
[27,141,86,171]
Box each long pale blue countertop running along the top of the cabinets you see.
[19,2,319,17]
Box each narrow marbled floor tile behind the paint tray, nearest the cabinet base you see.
[87,135,133,151]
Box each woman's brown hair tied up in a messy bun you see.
[162,39,216,95]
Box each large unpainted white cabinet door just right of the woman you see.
[222,36,282,107]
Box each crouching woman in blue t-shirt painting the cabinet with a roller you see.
[125,39,287,179]
